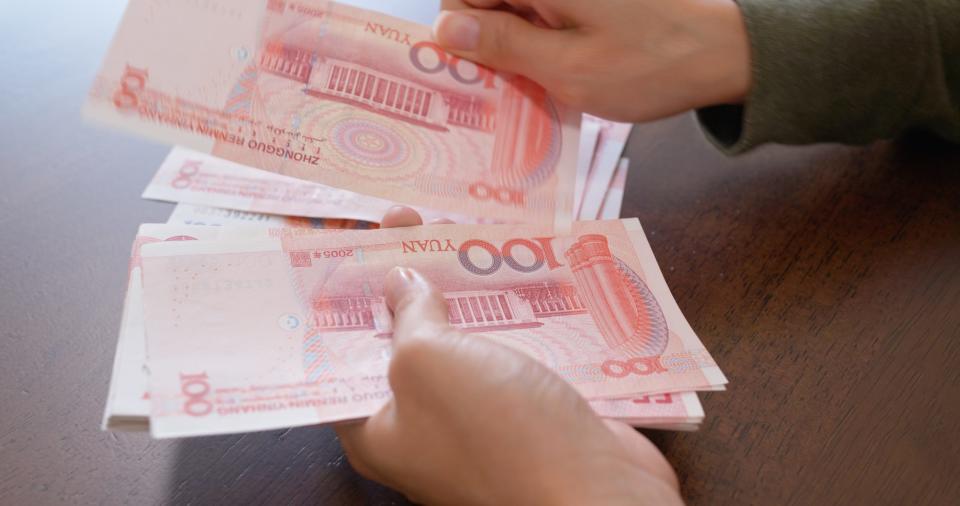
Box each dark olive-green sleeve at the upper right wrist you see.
[697,0,960,154]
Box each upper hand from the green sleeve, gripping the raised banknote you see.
[434,0,750,122]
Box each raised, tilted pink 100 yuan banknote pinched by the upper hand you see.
[85,0,580,225]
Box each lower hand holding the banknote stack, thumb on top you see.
[336,208,682,505]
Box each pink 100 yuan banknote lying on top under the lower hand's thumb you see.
[143,220,726,437]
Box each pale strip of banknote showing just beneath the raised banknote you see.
[149,147,494,226]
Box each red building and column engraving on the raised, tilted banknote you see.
[258,14,562,190]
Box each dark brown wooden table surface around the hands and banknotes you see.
[0,1,960,505]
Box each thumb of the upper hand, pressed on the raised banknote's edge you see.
[433,9,569,84]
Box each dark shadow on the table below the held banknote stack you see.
[164,428,409,505]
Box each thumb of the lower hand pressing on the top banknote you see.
[384,267,452,347]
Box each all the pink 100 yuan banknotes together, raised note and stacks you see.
[94,0,726,438]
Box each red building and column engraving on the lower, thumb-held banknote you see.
[311,235,669,356]
